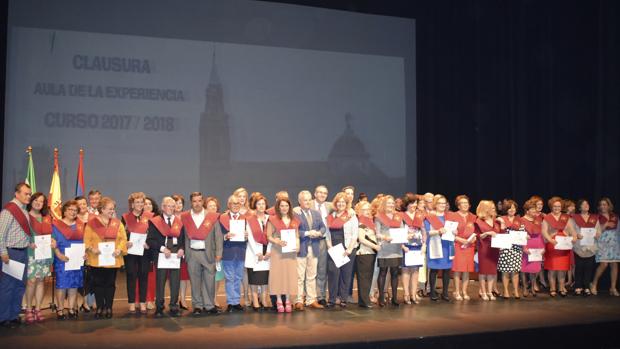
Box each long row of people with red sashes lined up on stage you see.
[0,183,620,326]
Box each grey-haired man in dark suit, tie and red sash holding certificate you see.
[146,196,185,317]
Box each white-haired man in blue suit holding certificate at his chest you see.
[219,195,248,313]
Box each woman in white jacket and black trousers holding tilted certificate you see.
[326,192,359,307]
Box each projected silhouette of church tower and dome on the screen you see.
[199,53,405,198]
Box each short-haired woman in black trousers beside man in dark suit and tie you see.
[121,192,153,314]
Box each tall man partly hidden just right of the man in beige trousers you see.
[312,184,332,306]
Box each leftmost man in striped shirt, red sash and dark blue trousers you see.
[0,182,32,327]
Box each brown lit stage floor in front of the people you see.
[0,285,620,349]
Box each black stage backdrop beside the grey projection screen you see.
[0,0,620,204]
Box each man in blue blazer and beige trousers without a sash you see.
[294,190,326,311]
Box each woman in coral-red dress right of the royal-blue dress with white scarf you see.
[447,195,477,301]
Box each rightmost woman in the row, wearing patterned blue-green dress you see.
[590,198,620,297]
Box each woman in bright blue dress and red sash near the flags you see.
[52,200,84,320]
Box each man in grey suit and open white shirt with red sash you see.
[181,192,224,316]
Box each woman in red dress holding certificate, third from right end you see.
[542,196,577,297]
